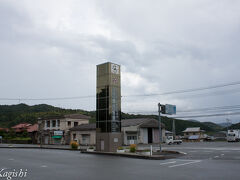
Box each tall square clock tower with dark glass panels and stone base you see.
[96,62,122,152]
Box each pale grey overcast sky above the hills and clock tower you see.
[0,0,240,122]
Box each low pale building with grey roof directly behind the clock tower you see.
[70,118,166,145]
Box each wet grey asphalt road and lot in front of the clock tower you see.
[0,142,240,180]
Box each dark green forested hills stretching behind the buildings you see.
[0,104,222,134]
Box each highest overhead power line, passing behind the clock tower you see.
[0,81,240,101]
